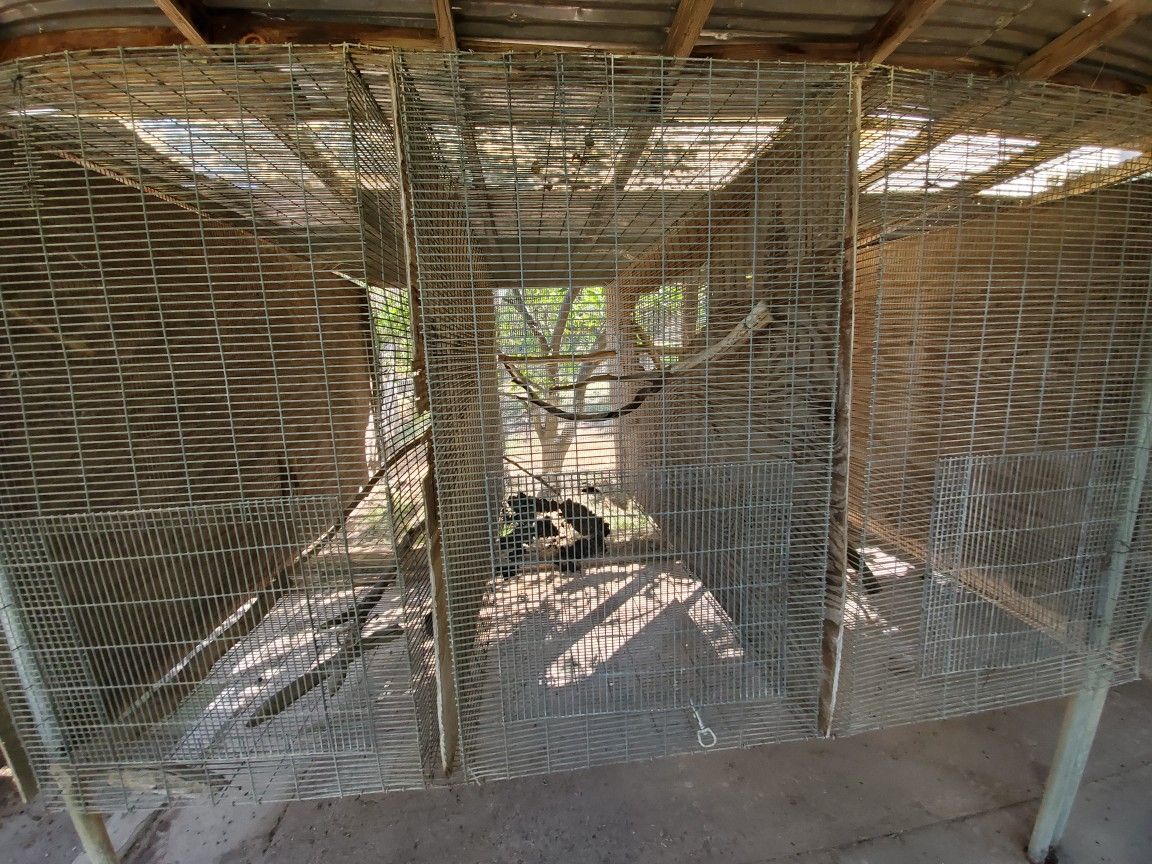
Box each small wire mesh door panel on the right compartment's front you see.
[920,447,1132,676]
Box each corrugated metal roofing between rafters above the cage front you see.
[0,0,1152,85]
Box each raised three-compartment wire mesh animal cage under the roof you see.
[0,38,1152,864]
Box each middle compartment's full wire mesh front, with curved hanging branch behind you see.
[402,54,854,778]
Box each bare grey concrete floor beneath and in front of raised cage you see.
[0,681,1152,864]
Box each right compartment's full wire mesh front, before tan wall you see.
[836,70,1152,733]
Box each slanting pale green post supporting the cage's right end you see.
[1028,343,1152,864]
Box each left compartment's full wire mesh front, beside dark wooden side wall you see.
[0,48,437,810]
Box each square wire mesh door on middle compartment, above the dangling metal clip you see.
[482,462,791,723]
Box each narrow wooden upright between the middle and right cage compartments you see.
[817,76,863,736]
